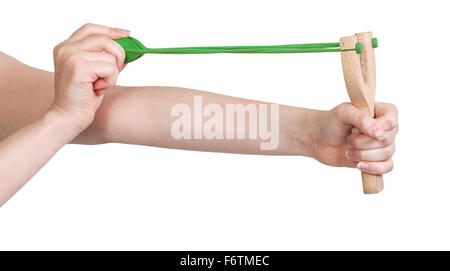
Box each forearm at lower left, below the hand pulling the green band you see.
[0,111,76,206]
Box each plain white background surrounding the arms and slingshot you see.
[0,0,450,250]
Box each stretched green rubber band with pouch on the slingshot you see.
[116,37,370,63]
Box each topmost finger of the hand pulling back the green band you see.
[68,23,130,42]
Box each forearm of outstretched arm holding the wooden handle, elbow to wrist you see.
[96,86,312,156]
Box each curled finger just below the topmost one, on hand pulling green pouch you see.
[72,35,125,68]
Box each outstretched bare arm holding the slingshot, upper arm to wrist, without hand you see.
[0,53,312,156]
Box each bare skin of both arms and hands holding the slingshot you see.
[0,24,398,206]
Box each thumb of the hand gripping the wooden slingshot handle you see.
[336,103,384,140]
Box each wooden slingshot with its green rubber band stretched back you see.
[116,32,383,194]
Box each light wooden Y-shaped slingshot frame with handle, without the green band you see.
[340,32,384,194]
